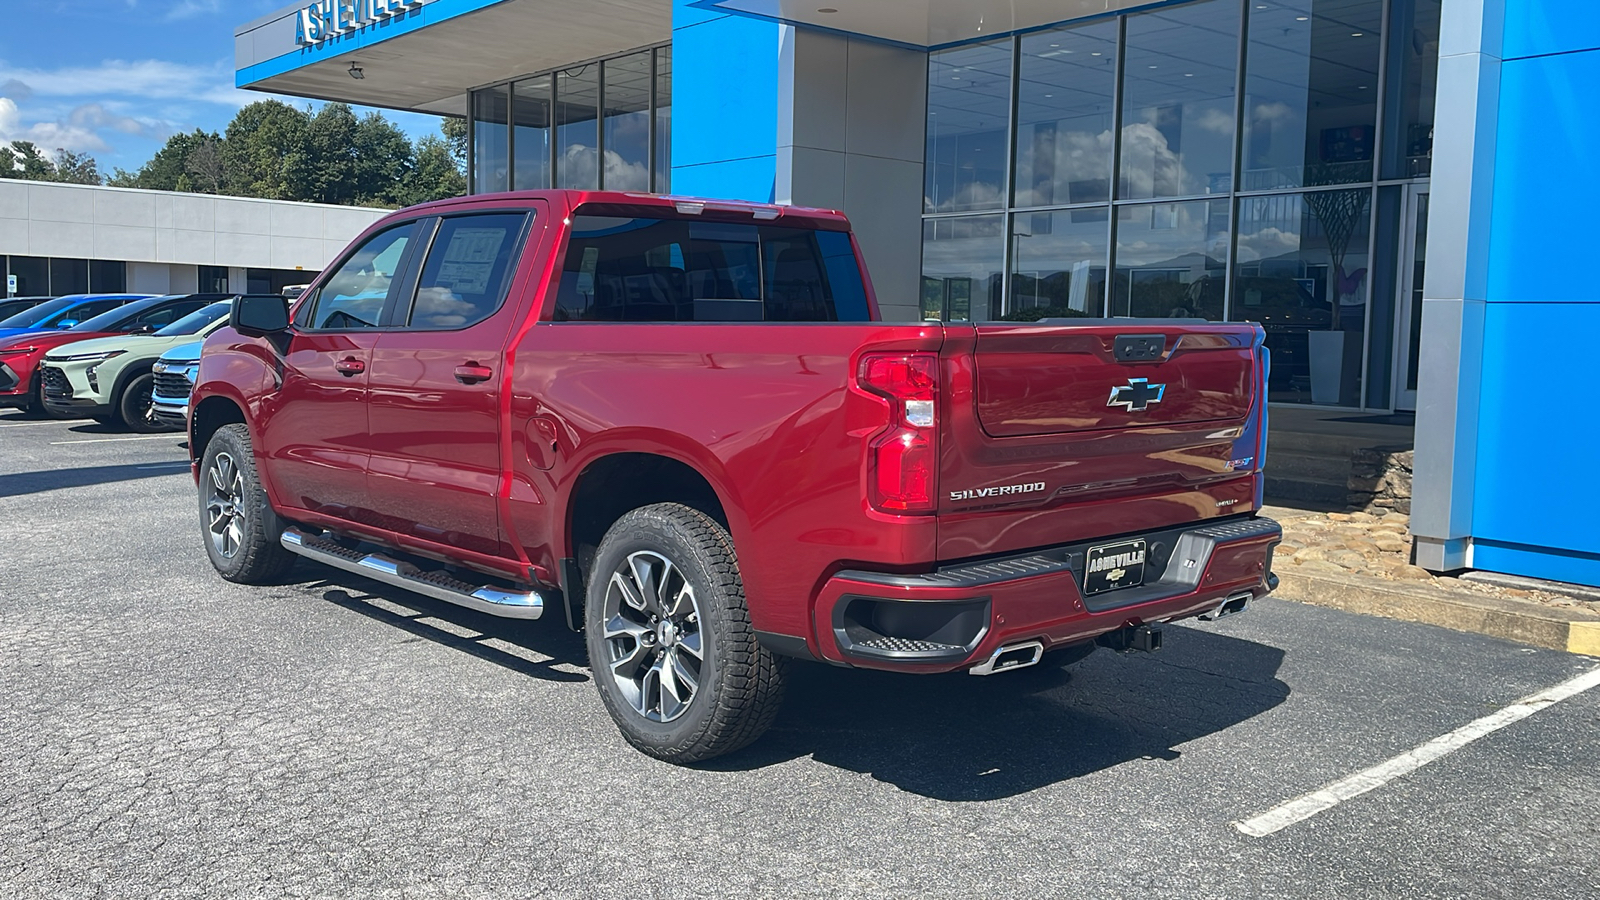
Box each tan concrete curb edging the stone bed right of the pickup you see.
[1272,567,1600,657]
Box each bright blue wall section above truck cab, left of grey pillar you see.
[672,0,779,202]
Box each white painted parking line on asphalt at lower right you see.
[1234,669,1600,838]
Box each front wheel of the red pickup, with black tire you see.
[197,424,294,585]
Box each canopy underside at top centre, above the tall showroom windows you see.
[694,0,1152,50]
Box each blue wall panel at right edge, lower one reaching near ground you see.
[1472,301,1600,583]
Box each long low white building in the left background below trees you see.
[0,179,387,296]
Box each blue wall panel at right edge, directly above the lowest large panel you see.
[1488,51,1600,303]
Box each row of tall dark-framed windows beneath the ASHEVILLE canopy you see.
[469,46,672,194]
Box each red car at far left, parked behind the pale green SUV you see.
[0,295,208,412]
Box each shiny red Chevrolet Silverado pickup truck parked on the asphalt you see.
[189,191,1282,762]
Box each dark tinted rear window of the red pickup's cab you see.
[555,216,867,322]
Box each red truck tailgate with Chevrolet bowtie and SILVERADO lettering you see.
[939,319,1266,559]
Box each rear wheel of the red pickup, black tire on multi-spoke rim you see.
[584,503,787,764]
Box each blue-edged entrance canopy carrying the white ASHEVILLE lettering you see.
[234,0,672,115]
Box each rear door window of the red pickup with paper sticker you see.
[406,213,526,328]
